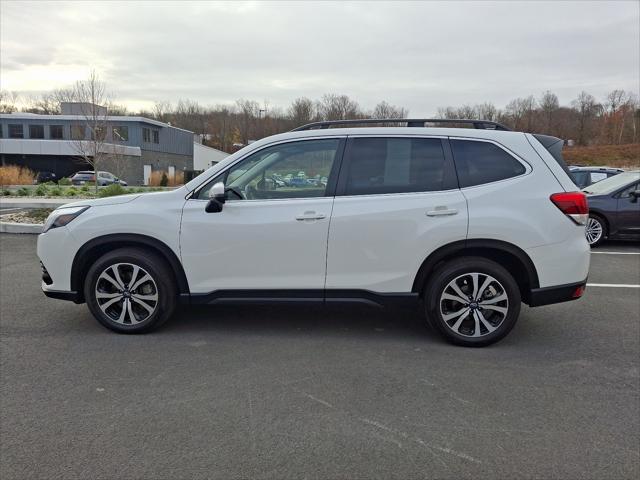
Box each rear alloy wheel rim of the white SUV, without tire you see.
[440,272,509,338]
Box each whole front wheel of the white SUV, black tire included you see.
[84,247,177,333]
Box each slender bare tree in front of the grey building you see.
[71,71,113,194]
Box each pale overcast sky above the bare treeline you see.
[0,0,640,116]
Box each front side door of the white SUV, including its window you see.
[180,137,344,292]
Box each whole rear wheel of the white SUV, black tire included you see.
[424,257,521,347]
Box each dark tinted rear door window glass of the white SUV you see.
[345,138,453,195]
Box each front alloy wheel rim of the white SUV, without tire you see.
[95,263,158,325]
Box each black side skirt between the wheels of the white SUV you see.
[180,289,419,307]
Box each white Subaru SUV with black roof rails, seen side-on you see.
[38,120,589,346]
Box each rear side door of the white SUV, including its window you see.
[326,136,468,297]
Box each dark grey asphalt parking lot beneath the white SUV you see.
[0,234,640,480]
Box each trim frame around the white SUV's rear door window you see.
[336,133,459,198]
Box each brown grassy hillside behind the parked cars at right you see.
[562,143,640,168]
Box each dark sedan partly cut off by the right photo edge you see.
[582,170,640,246]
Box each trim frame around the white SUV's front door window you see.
[186,135,347,203]
